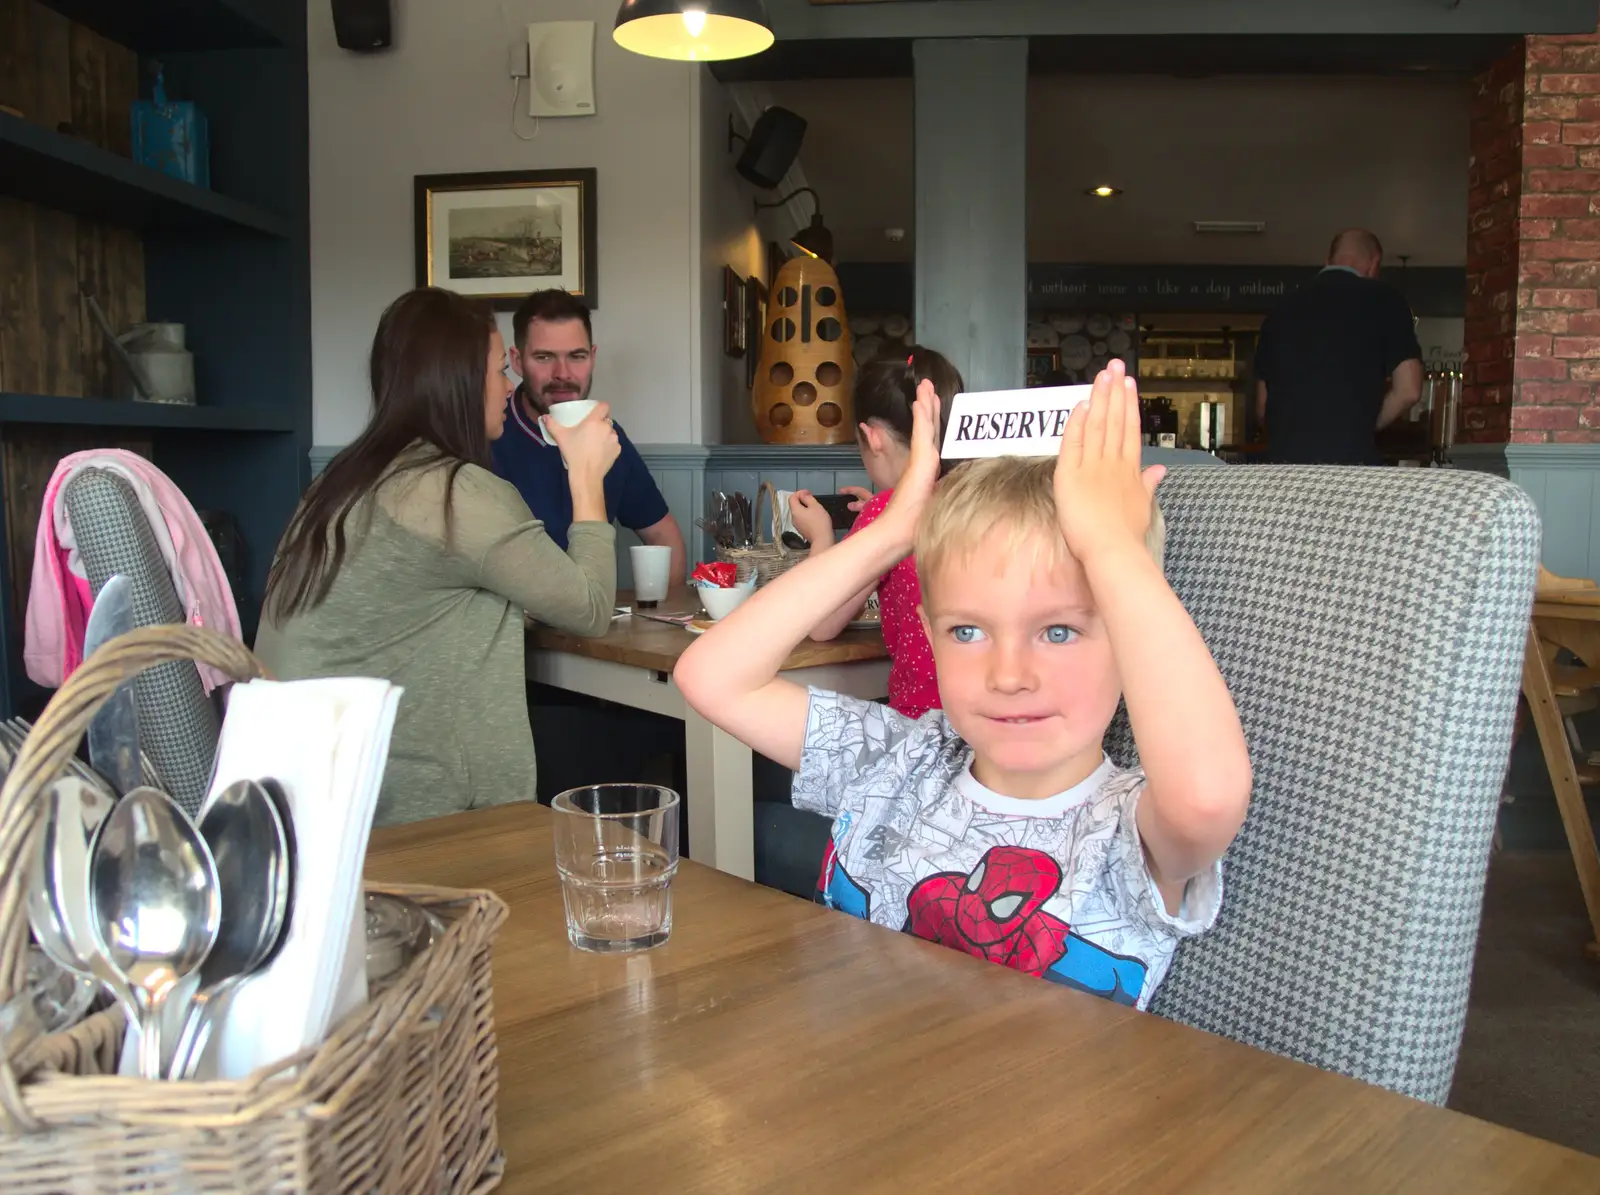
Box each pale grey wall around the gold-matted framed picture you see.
[307,0,697,445]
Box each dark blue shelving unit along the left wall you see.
[0,0,312,712]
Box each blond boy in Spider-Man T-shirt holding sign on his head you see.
[674,363,1251,1008]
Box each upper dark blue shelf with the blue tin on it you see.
[0,112,290,238]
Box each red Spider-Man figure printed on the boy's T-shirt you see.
[906,846,1069,976]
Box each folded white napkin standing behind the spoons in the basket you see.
[122,677,402,1078]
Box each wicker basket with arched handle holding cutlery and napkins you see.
[0,625,506,1195]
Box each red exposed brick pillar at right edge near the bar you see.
[1458,26,1600,443]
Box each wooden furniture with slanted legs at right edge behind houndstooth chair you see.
[1522,576,1600,961]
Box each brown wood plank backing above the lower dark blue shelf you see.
[0,0,146,397]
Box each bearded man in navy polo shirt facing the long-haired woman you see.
[494,290,688,584]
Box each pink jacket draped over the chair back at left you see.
[22,448,242,691]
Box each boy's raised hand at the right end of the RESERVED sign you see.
[1056,360,1166,563]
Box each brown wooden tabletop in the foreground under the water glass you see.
[368,805,1600,1195]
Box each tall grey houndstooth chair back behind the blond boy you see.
[1107,466,1539,1104]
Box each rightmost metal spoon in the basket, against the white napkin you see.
[166,781,294,1078]
